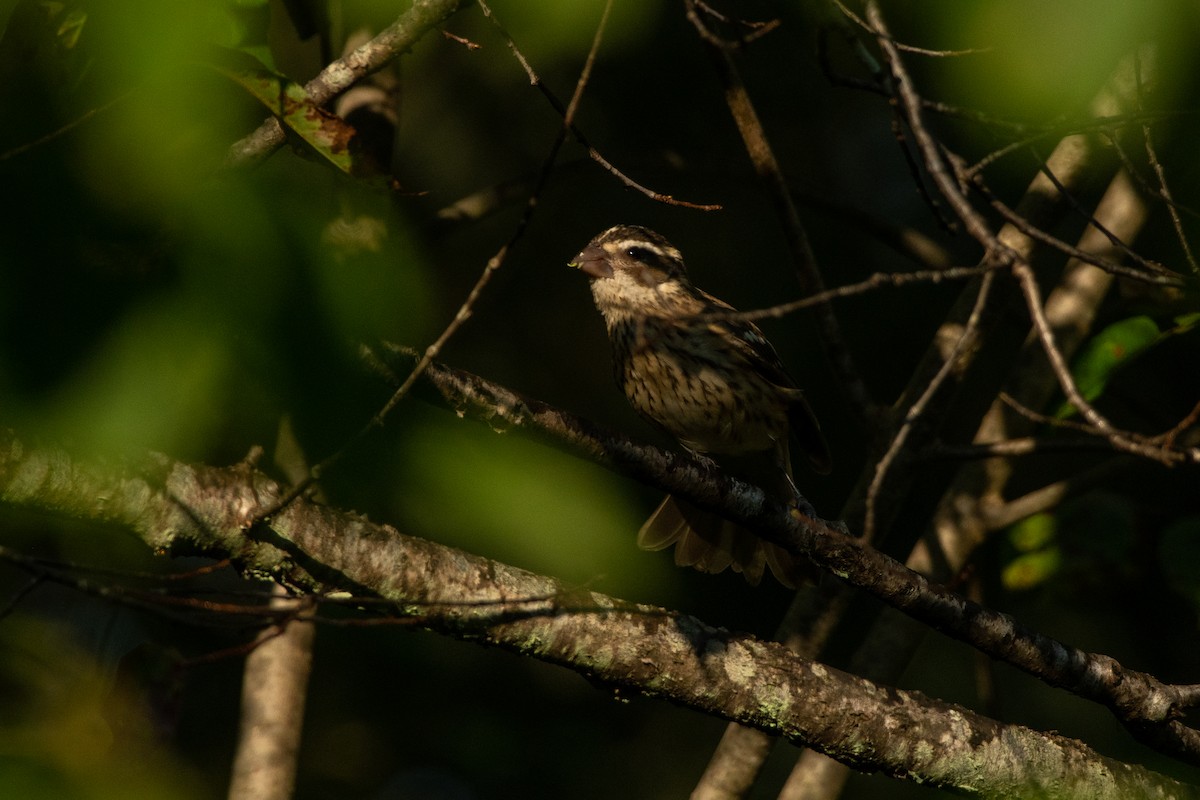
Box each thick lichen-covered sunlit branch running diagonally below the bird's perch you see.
[0,437,1200,798]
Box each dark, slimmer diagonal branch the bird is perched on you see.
[372,352,1200,763]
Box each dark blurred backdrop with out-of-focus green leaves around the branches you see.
[0,0,1200,798]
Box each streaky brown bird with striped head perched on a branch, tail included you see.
[570,225,830,587]
